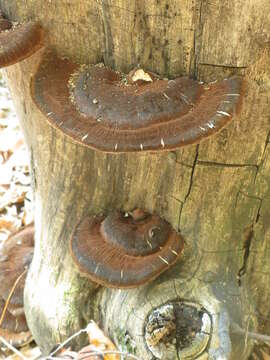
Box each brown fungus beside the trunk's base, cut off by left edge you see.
[0,225,34,346]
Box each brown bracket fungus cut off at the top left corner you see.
[0,13,44,67]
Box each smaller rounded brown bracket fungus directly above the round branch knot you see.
[70,210,184,288]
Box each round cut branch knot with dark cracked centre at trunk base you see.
[145,300,213,360]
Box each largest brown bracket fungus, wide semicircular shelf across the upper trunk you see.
[32,53,242,153]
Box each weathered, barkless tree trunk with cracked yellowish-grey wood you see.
[0,0,270,359]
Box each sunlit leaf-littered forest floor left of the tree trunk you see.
[0,73,36,360]
